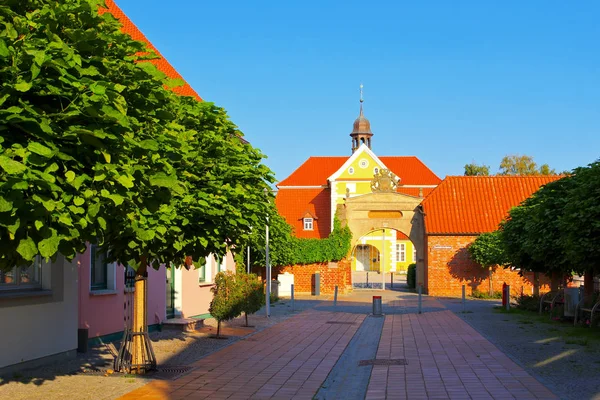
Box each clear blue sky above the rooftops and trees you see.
[117,0,600,180]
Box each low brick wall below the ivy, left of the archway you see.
[253,260,352,294]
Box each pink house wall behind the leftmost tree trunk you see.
[76,247,166,338]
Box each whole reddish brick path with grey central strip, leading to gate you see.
[122,292,556,400]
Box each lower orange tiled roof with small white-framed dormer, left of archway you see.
[275,188,331,238]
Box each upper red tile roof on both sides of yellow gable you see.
[277,156,441,188]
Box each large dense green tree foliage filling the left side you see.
[0,0,274,268]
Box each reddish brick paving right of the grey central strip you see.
[366,311,556,400]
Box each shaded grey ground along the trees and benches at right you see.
[438,299,600,400]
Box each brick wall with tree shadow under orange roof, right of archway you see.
[425,235,549,296]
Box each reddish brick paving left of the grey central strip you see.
[116,310,364,400]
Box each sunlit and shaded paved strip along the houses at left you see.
[0,296,328,400]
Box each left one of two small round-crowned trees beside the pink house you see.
[208,271,243,337]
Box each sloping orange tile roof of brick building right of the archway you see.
[422,176,561,235]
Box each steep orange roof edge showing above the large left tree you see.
[98,0,202,101]
